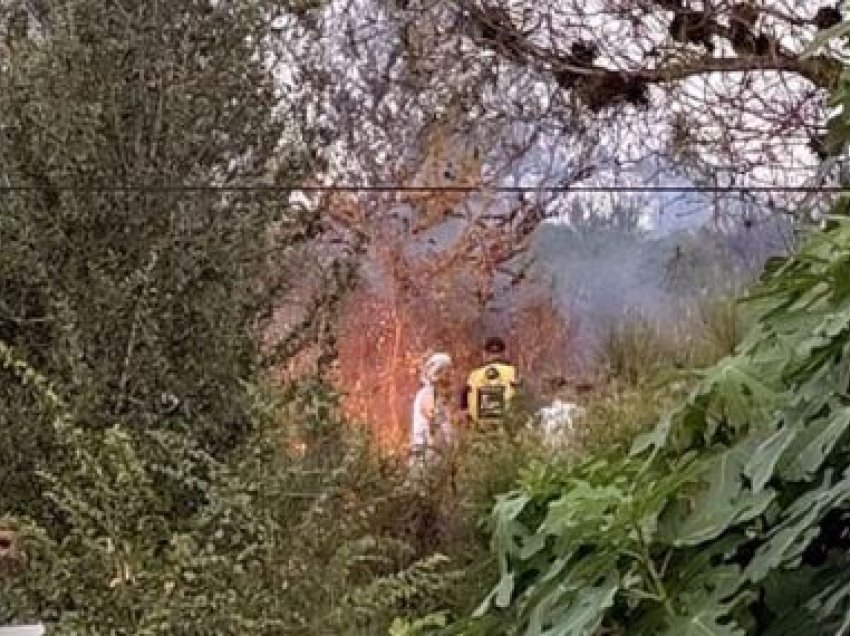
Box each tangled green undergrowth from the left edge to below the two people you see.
[0,296,736,636]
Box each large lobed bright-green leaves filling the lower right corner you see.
[450,218,850,636]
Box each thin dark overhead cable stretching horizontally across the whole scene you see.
[0,184,850,194]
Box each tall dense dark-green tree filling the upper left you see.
[0,0,320,514]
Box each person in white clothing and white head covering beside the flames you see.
[410,353,453,464]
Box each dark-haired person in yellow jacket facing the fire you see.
[460,336,520,424]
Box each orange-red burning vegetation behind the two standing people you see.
[338,235,573,448]
